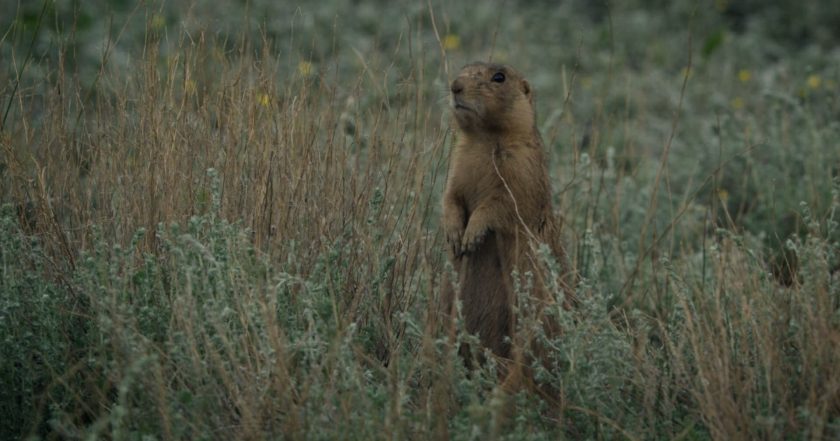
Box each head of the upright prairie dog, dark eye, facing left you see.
[450,63,534,133]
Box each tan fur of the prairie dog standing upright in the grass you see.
[443,63,574,365]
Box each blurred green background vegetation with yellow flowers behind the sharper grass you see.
[0,0,840,248]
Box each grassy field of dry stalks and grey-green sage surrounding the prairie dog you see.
[0,0,840,440]
